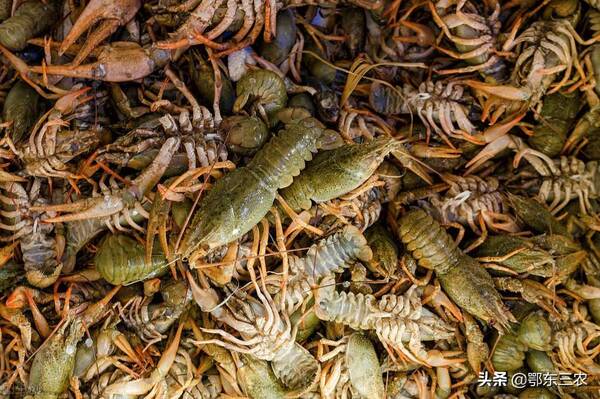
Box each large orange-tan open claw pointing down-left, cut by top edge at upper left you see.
[58,0,142,65]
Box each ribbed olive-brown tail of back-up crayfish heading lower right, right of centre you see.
[398,209,464,274]
